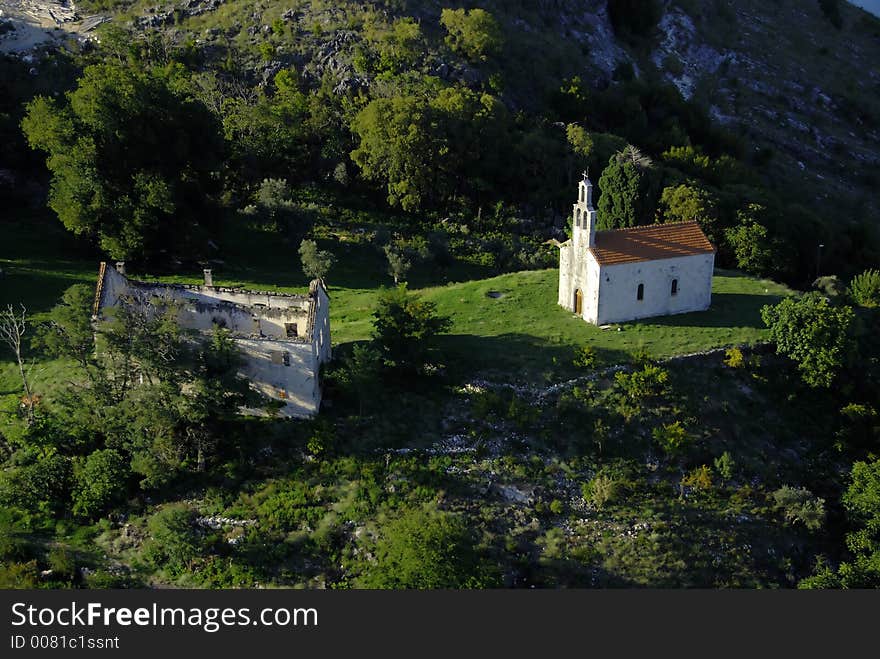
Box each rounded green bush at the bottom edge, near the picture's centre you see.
[359,508,492,590]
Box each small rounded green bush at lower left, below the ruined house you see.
[73,449,128,519]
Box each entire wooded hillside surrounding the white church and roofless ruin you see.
[0,0,880,589]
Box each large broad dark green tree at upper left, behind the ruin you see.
[22,64,223,259]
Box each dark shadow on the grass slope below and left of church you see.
[437,334,631,383]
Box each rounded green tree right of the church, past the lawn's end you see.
[761,293,856,387]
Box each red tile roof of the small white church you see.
[590,222,715,265]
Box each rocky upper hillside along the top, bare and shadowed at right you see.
[5,0,880,222]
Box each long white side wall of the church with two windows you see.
[595,254,715,325]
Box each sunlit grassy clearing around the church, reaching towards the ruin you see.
[331,270,792,380]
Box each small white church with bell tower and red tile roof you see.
[559,174,715,325]
